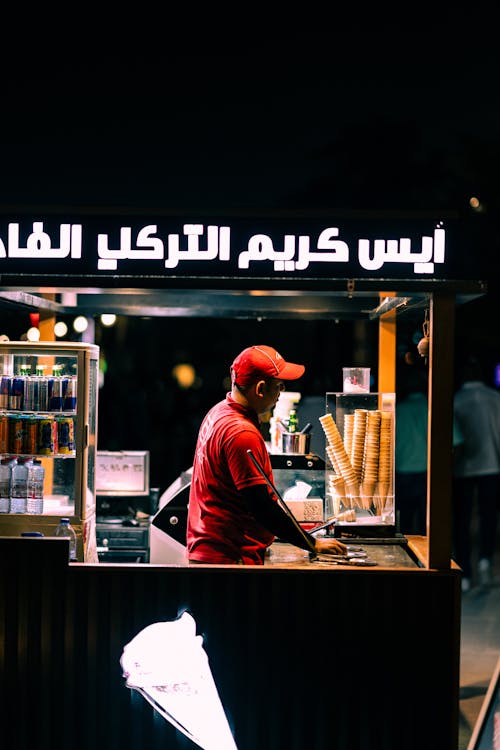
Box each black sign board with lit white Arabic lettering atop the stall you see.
[0,215,468,286]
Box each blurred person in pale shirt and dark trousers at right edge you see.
[453,357,500,593]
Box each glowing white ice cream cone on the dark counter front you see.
[120,612,237,750]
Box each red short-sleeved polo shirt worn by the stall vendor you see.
[187,393,274,565]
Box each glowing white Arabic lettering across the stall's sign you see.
[0,221,446,275]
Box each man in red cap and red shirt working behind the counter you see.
[187,345,346,565]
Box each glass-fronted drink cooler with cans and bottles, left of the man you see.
[0,341,99,562]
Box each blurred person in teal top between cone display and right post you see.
[395,364,463,536]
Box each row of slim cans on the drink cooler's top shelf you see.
[0,375,77,411]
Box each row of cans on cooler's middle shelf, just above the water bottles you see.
[0,414,75,456]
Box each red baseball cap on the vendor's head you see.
[231,345,306,388]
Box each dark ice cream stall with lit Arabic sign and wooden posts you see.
[0,207,486,750]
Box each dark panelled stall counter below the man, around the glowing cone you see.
[0,538,460,750]
